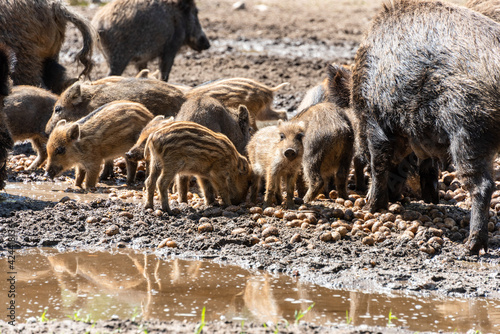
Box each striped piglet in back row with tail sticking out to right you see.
[186,78,288,130]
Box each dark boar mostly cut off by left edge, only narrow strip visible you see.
[0,43,15,190]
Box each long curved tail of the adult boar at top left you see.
[53,2,97,78]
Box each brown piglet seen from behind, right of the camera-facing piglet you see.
[293,102,354,203]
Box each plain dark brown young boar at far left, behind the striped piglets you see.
[4,85,58,170]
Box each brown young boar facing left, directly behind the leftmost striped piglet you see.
[45,77,185,133]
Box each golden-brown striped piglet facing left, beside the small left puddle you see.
[45,101,153,189]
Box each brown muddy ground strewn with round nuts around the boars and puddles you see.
[0,0,500,333]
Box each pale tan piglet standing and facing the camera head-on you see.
[247,120,306,209]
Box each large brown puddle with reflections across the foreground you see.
[0,248,500,333]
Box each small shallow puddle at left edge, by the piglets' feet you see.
[0,181,142,203]
